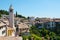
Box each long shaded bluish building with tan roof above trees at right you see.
[35,18,60,29]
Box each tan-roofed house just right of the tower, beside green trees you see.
[17,23,29,36]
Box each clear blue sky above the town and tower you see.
[0,0,60,18]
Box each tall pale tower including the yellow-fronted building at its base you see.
[7,5,15,36]
